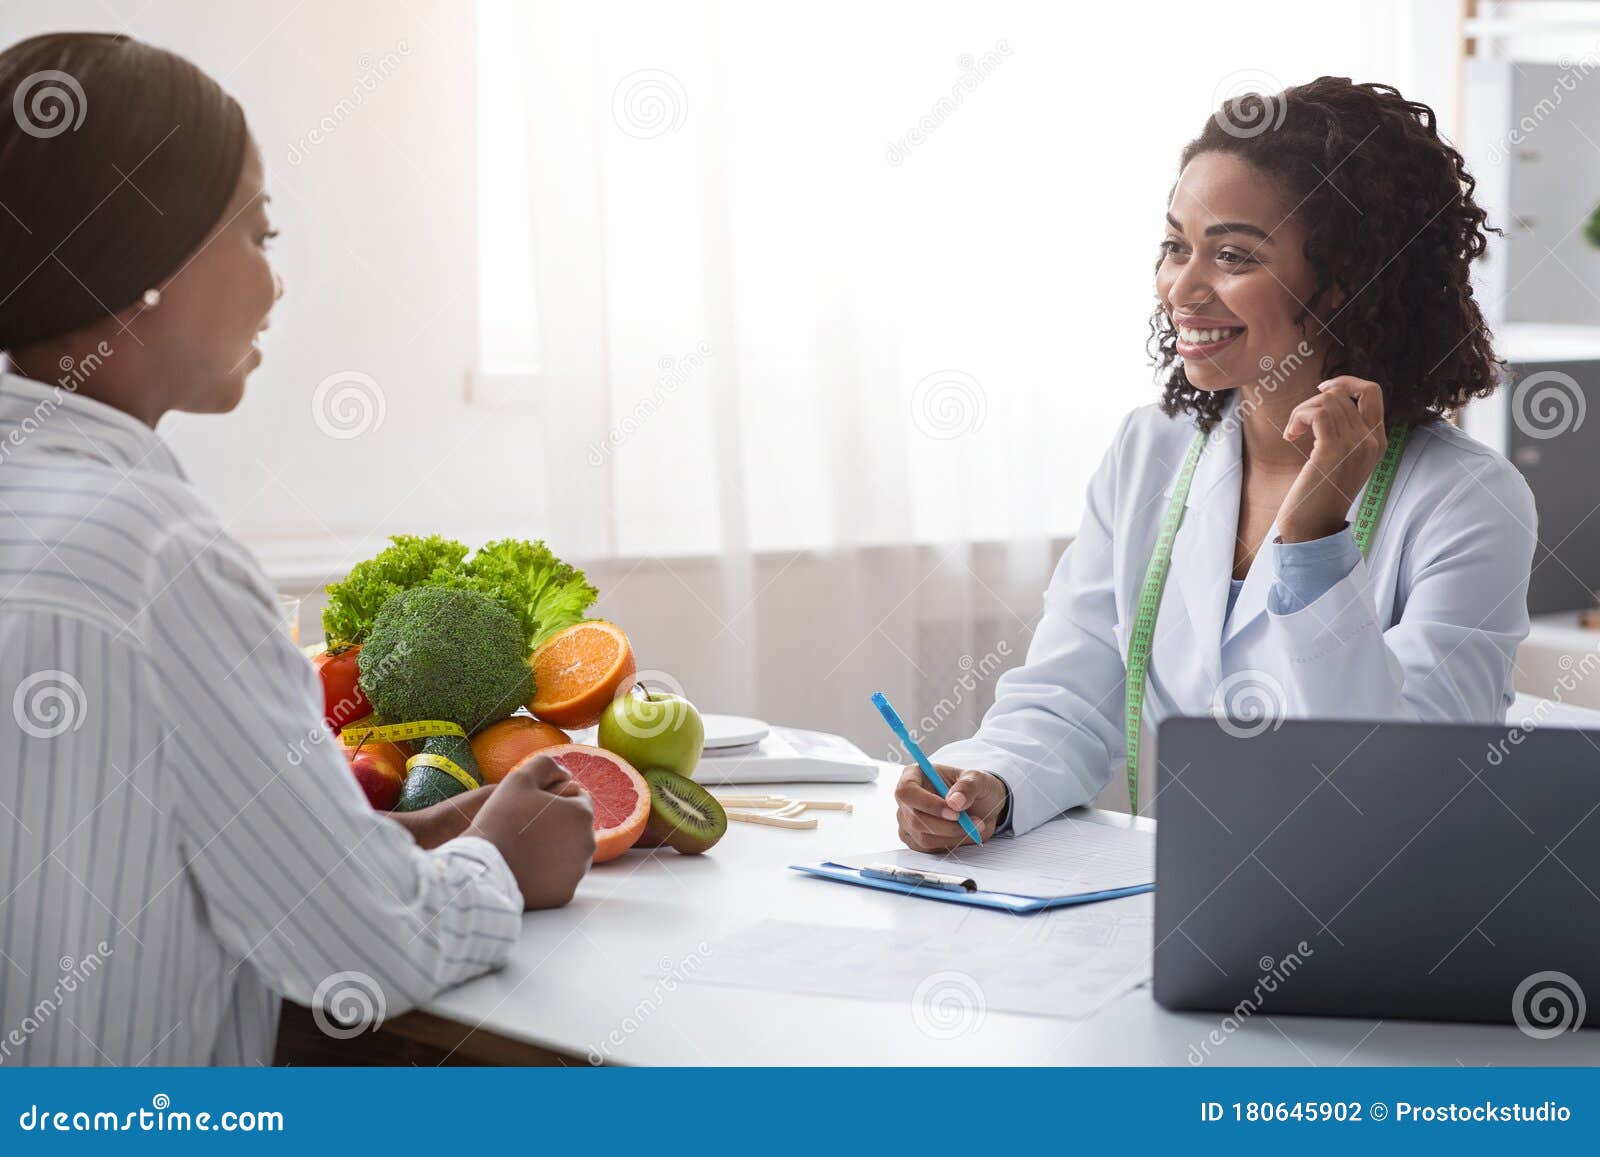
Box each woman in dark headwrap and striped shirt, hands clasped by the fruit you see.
[0,34,594,1064]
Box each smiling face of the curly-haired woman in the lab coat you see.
[1155,152,1322,390]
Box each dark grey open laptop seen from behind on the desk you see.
[1154,717,1600,1035]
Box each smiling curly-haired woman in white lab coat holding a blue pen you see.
[896,77,1536,851]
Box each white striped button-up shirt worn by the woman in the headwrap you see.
[0,374,522,1064]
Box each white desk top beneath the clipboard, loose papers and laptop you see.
[426,768,1600,1066]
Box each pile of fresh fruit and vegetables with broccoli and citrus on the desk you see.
[314,534,728,864]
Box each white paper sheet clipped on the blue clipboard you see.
[832,816,1155,896]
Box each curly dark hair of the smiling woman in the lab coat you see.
[1150,77,1499,430]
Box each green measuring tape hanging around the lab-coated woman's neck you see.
[1123,426,1410,815]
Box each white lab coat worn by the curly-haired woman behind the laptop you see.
[933,400,1536,834]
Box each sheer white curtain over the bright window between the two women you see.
[478,0,1427,761]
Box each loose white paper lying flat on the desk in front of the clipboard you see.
[686,895,1154,1019]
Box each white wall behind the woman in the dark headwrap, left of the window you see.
[0,0,546,570]
